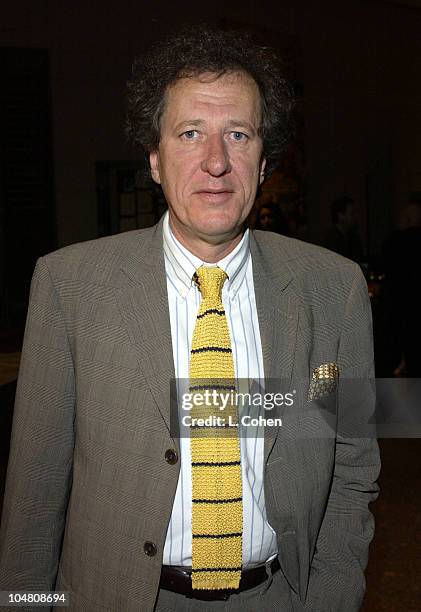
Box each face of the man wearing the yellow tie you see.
[150,73,265,252]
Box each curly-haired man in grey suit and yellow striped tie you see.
[0,28,379,612]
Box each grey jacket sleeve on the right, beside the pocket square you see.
[305,266,380,612]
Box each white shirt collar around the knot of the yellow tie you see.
[163,211,250,298]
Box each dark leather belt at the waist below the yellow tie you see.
[159,557,281,601]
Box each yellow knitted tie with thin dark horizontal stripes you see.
[189,266,243,589]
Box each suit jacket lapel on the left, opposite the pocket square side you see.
[116,220,177,443]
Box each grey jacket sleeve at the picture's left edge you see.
[0,258,74,610]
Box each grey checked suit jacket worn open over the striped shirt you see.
[0,221,379,612]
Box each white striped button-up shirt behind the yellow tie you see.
[163,212,277,567]
